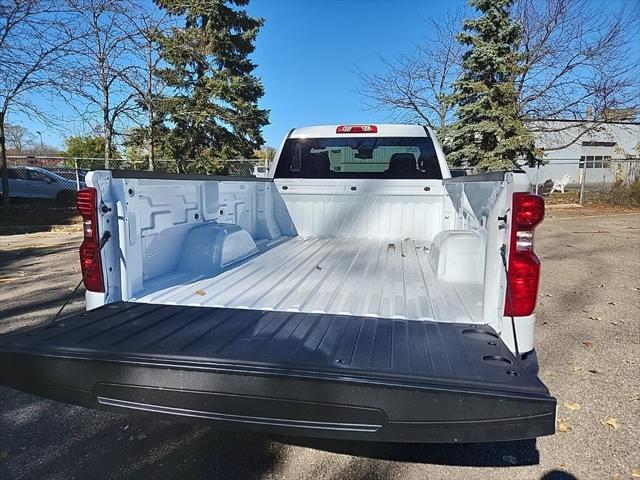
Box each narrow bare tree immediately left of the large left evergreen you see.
[122,8,169,171]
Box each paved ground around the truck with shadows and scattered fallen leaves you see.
[0,210,640,480]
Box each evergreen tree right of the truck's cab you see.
[447,0,535,171]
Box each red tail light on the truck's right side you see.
[504,192,544,317]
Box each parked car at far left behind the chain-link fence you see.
[0,167,86,204]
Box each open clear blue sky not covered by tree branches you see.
[9,0,637,147]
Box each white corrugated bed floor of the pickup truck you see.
[133,237,482,322]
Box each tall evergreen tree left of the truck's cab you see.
[155,0,269,173]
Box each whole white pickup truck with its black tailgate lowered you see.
[0,125,556,442]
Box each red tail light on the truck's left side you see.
[76,187,104,292]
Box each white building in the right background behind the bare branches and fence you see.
[524,120,640,187]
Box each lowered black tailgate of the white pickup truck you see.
[0,303,555,442]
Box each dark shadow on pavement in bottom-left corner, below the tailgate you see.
[0,388,281,480]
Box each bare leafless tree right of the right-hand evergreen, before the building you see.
[514,0,640,150]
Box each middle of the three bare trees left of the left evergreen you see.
[67,0,138,169]
